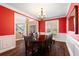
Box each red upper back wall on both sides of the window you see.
[38,17,67,33]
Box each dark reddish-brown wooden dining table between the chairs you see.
[32,35,47,55]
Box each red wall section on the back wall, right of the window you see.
[59,17,67,33]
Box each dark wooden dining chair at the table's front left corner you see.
[24,36,38,56]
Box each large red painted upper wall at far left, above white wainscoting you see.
[0,6,14,36]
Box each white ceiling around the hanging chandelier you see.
[4,3,69,19]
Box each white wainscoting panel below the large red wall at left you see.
[0,35,16,53]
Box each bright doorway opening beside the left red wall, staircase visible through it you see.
[14,13,26,41]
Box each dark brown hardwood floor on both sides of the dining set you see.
[0,40,69,56]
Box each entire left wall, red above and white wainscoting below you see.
[0,5,16,53]
